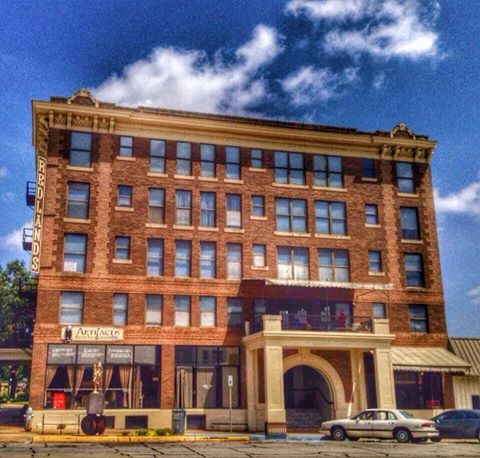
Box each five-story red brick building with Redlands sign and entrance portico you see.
[26,90,468,434]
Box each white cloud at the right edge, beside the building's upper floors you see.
[434,181,480,216]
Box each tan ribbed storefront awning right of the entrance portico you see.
[392,347,470,372]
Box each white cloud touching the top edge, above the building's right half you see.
[287,0,440,59]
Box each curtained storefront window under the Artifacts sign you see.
[45,345,160,409]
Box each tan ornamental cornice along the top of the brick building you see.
[32,92,436,163]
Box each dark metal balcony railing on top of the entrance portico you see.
[250,313,372,334]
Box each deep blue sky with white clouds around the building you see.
[0,0,480,335]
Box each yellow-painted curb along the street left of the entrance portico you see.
[32,434,249,444]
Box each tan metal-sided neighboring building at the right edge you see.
[449,337,480,410]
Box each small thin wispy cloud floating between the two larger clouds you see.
[281,65,357,106]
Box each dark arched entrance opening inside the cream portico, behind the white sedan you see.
[283,365,334,431]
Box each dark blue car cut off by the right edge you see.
[432,409,480,441]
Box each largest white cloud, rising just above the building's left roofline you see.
[92,25,283,113]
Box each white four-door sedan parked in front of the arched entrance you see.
[320,409,439,443]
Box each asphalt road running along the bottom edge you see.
[0,441,480,458]
